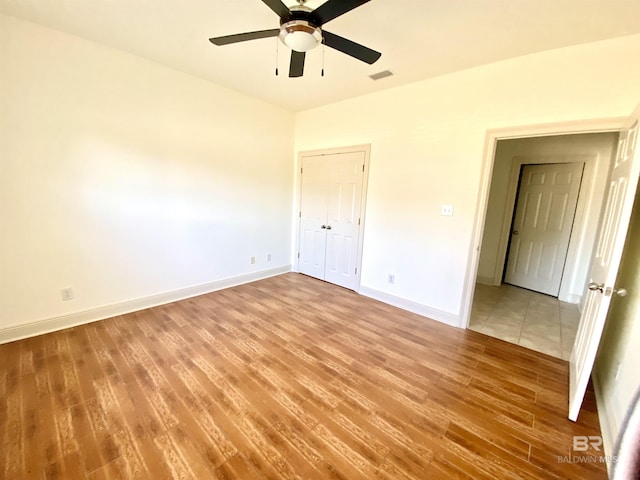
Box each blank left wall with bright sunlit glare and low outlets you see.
[0,16,294,340]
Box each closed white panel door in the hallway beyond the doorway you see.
[505,162,584,297]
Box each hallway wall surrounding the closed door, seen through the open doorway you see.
[477,132,618,303]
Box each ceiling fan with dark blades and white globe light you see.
[209,0,382,77]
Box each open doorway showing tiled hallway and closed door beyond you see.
[468,132,618,360]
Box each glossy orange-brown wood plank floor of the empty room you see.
[0,274,606,480]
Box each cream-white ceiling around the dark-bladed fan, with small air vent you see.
[0,0,640,111]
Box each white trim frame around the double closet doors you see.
[292,144,371,292]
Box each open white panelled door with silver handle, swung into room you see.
[569,106,640,421]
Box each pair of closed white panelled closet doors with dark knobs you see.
[298,151,365,289]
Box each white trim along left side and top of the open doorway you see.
[460,117,627,328]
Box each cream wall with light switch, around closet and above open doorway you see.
[295,35,640,324]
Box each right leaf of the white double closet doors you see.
[325,152,364,290]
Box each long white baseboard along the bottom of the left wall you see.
[0,265,291,344]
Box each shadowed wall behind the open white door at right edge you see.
[594,190,640,455]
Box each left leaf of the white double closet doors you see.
[298,156,327,280]
